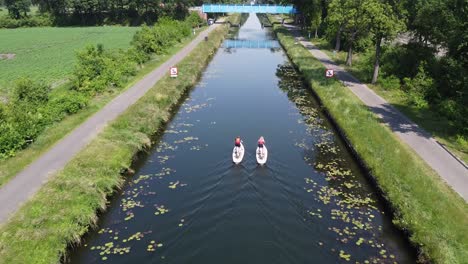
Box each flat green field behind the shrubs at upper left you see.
[0,26,138,94]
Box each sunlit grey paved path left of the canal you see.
[0,24,224,223]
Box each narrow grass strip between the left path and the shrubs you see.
[0,28,205,187]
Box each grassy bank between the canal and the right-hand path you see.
[270,17,468,263]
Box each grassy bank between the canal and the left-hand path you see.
[0,15,240,263]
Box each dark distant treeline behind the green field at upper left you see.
[0,0,200,27]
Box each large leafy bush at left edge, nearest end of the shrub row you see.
[0,79,88,159]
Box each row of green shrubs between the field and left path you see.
[0,14,204,160]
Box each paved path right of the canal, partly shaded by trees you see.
[287,25,468,202]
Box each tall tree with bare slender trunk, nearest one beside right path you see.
[364,0,405,84]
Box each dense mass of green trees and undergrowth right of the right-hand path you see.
[274,0,468,136]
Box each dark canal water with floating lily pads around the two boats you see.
[68,14,415,263]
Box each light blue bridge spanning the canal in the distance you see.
[202,4,298,14]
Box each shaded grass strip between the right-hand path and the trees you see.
[310,38,468,163]
